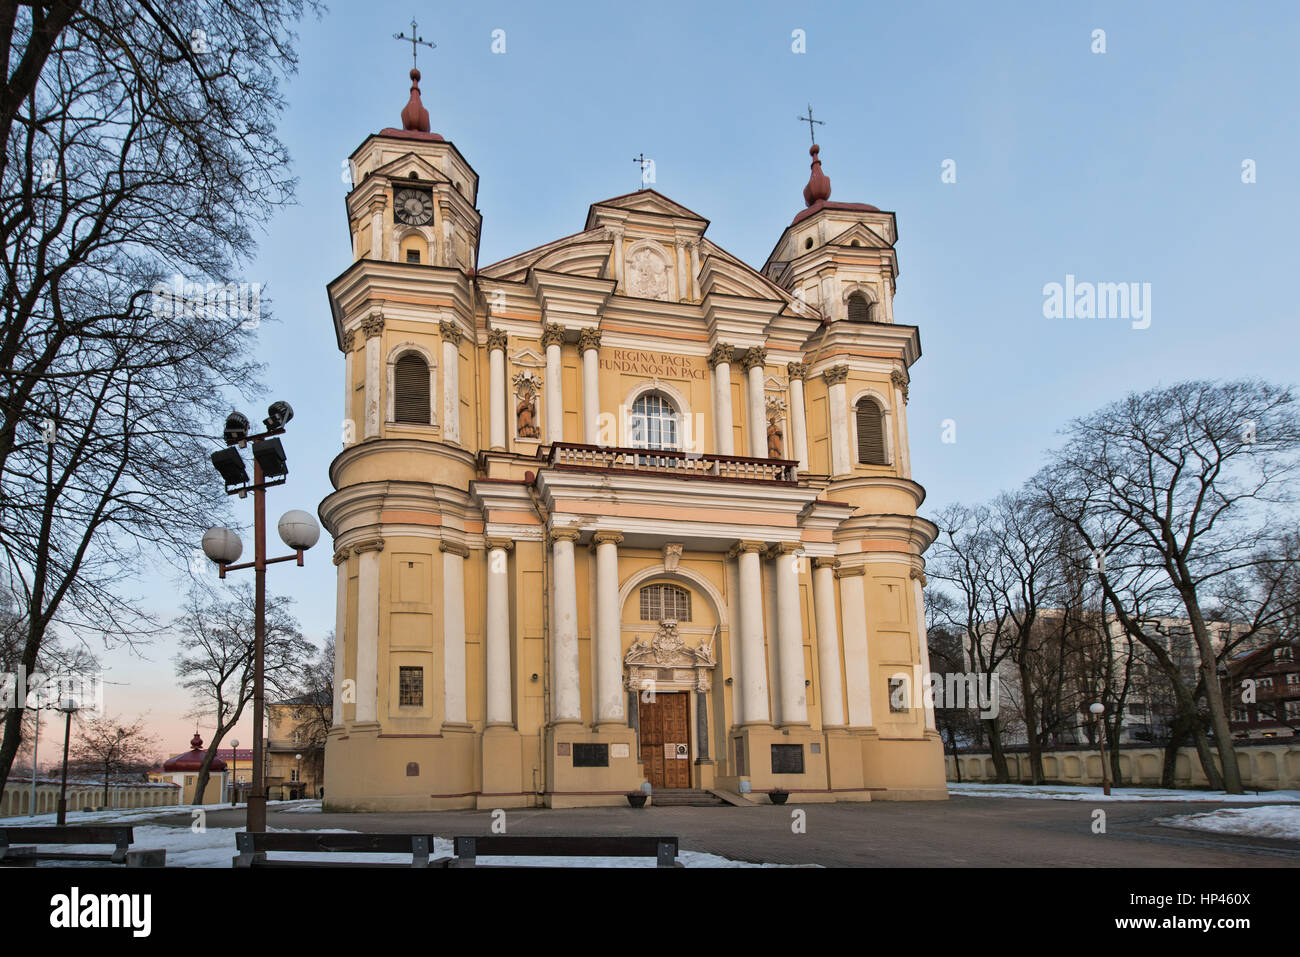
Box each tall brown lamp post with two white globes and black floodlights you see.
[203,402,321,833]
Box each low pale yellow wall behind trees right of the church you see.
[945,744,1300,791]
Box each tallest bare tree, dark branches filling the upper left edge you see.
[0,0,313,793]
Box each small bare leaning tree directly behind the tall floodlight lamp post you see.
[174,585,316,804]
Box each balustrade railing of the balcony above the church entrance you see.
[549,442,798,485]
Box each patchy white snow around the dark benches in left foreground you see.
[0,801,785,867]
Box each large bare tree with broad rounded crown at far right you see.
[1035,381,1300,793]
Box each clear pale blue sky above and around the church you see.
[83,1,1300,752]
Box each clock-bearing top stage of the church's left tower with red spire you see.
[347,68,481,273]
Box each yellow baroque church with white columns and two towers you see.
[320,69,946,810]
